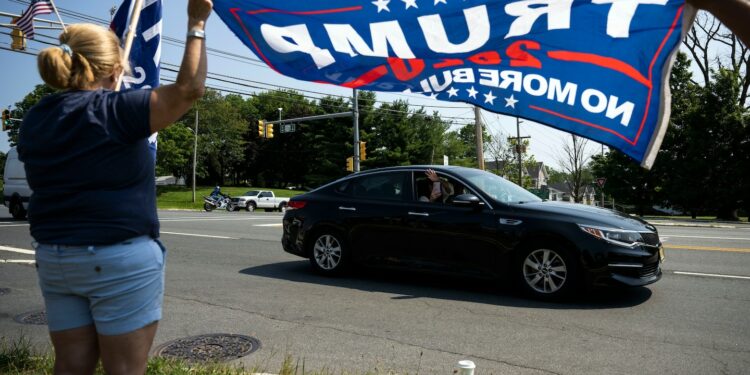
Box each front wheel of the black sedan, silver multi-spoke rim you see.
[516,245,578,300]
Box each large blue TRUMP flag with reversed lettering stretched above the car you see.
[214,0,694,167]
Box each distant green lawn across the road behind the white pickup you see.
[156,186,304,210]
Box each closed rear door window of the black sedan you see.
[342,172,406,200]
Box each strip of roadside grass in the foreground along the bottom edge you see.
[0,337,400,375]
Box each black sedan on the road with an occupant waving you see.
[282,166,664,299]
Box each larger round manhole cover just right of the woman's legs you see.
[154,333,260,362]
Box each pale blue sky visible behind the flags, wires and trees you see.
[0,0,601,170]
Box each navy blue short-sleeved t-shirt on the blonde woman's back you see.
[18,90,159,245]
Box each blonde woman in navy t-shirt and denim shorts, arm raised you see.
[18,0,213,374]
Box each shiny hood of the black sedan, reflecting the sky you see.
[514,201,656,232]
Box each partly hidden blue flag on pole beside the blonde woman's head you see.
[110,0,162,161]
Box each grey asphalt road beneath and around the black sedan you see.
[0,207,750,374]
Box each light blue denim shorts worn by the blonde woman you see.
[35,236,166,336]
